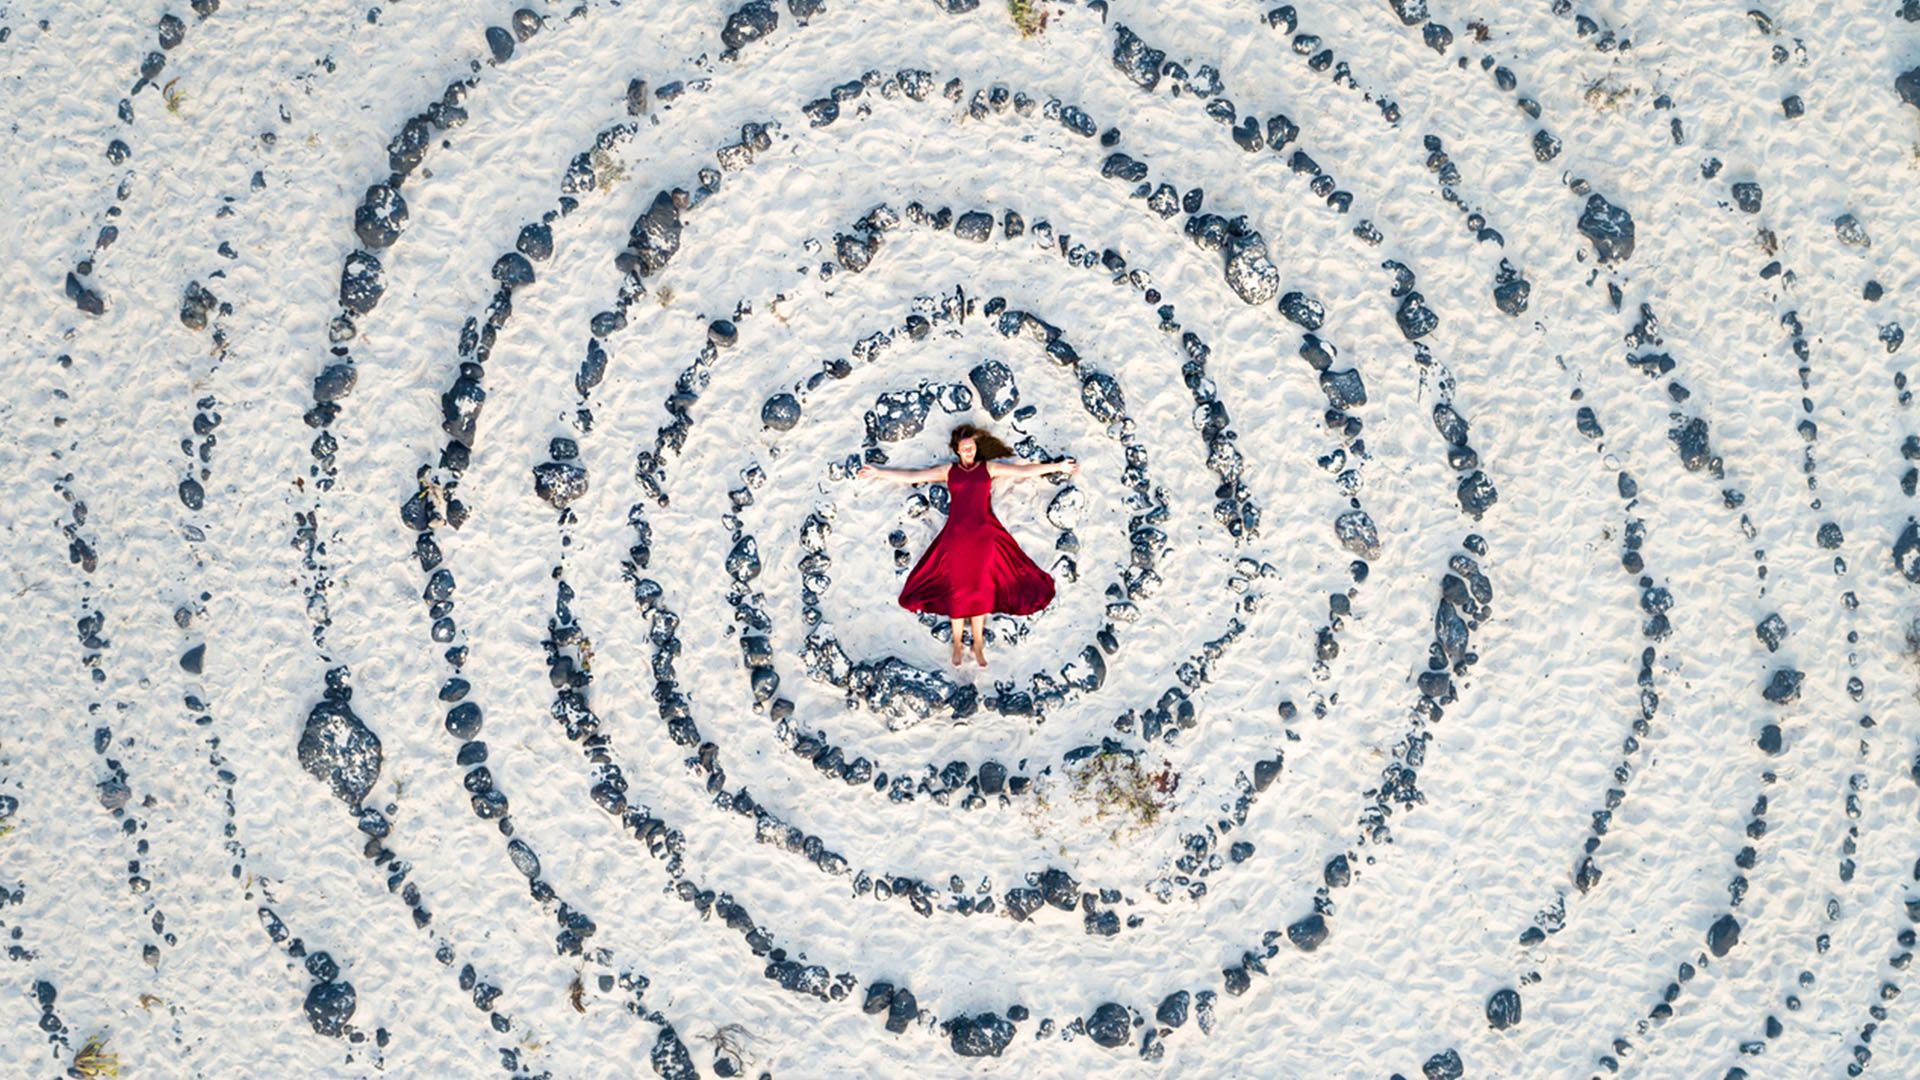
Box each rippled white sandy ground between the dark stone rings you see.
[0,0,1920,1078]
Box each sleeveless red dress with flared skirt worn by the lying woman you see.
[900,461,1054,619]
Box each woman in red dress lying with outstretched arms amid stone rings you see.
[856,425,1079,667]
